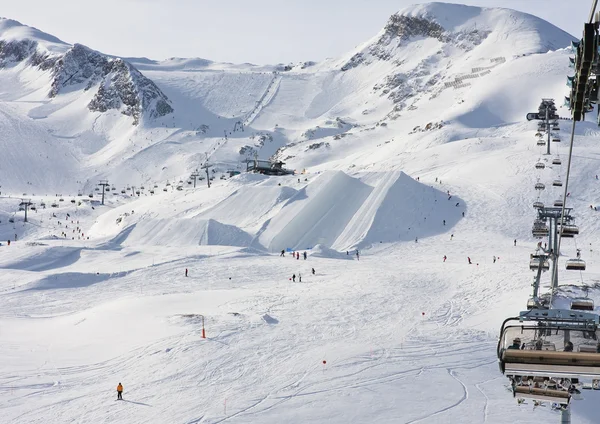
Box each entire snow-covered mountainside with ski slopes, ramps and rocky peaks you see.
[0,3,600,423]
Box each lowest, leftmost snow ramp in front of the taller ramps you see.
[113,218,252,247]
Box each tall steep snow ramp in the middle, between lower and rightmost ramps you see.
[259,171,373,252]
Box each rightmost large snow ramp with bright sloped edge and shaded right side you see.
[331,171,465,251]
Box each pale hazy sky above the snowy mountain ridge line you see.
[0,0,592,64]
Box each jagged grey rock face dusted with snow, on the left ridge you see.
[0,39,173,125]
